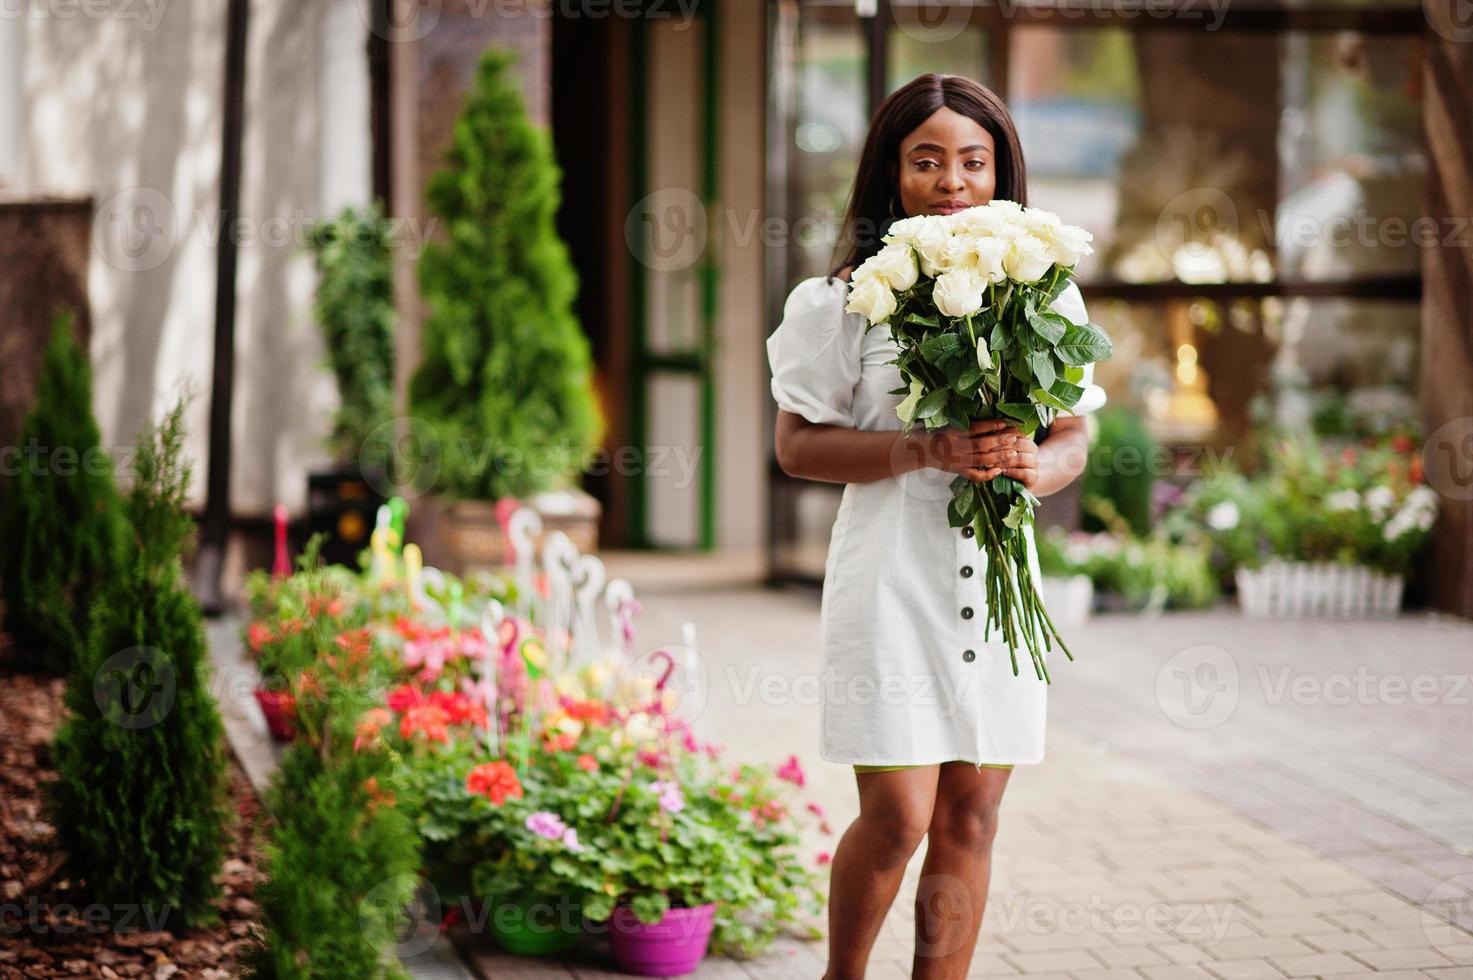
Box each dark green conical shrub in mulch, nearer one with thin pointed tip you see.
[50,402,228,930]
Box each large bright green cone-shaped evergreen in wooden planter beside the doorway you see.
[409,49,602,500]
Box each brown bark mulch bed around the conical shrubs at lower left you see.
[0,637,261,980]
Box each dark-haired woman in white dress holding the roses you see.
[767,74,1105,980]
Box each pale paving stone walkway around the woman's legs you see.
[210,556,1473,980]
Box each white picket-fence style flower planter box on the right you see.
[1234,561,1404,619]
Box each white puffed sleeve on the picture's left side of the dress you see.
[767,276,865,429]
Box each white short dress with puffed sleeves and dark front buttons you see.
[767,277,1105,766]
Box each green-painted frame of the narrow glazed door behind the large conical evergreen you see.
[629,0,720,551]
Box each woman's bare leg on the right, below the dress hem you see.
[910,762,1012,980]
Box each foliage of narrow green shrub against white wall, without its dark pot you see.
[309,205,395,460]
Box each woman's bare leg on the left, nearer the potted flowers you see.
[823,766,940,980]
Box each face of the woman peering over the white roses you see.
[900,106,997,217]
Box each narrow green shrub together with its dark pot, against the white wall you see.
[306,205,396,566]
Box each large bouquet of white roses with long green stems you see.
[846,200,1112,681]
